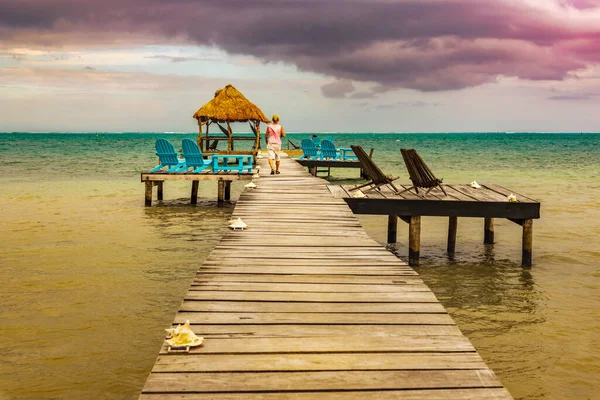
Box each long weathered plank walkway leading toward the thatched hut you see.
[140,158,512,400]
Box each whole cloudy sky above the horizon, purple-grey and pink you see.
[0,0,600,132]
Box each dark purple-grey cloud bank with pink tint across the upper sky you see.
[0,0,600,91]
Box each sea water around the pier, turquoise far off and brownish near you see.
[0,133,600,399]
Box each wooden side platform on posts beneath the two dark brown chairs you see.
[329,183,540,267]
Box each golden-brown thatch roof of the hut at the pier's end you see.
[194,85,269,122]
